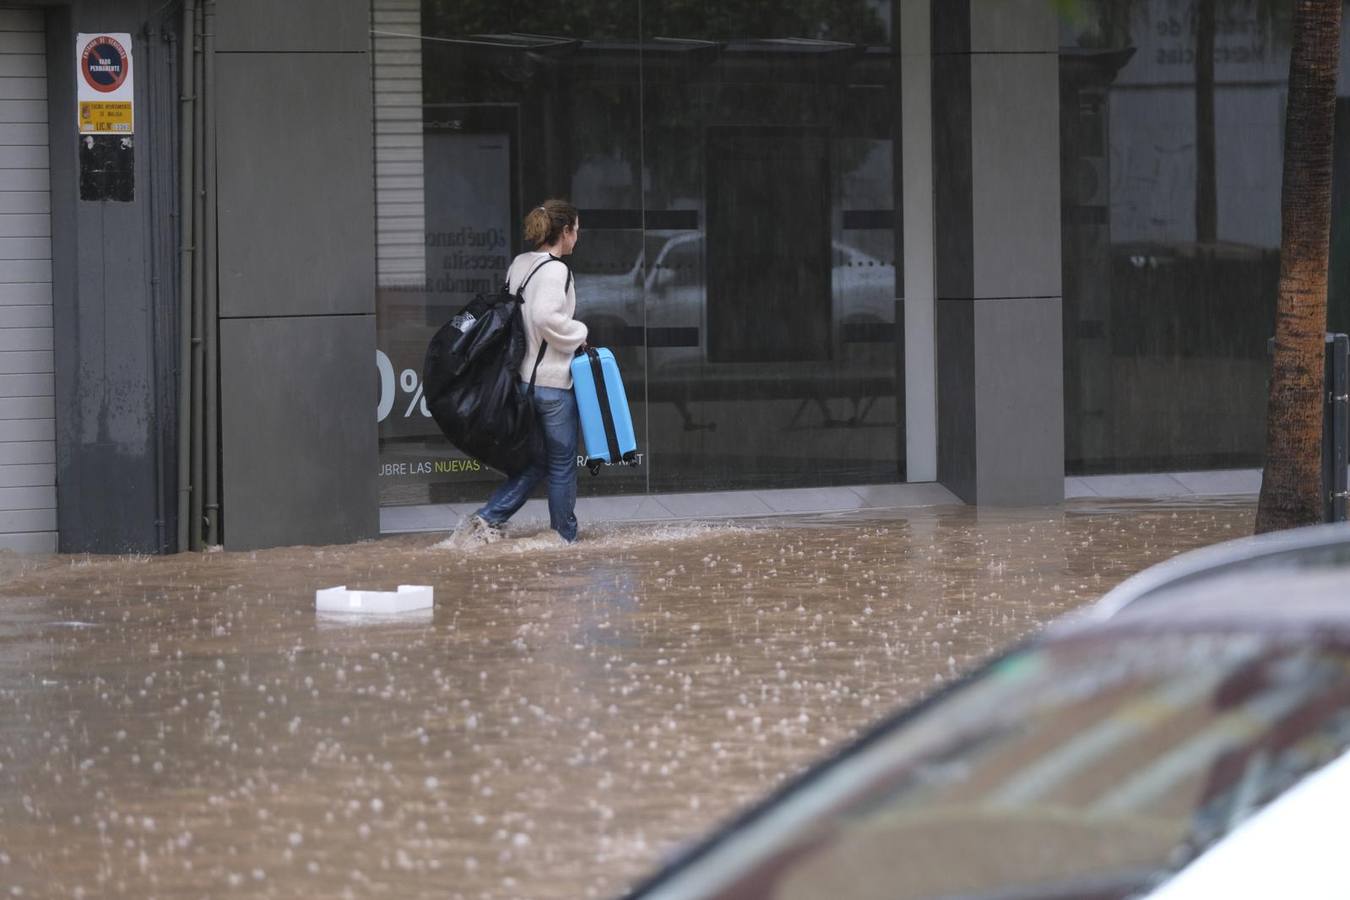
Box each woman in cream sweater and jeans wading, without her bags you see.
[466,200,586,544]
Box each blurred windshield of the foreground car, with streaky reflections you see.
[651,633,1350,900]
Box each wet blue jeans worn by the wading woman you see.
[477,385,581,544]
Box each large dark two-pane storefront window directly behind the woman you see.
[374,0,905,505]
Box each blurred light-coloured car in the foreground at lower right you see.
[618,525,1350,900]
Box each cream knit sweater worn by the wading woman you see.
[506,251,586,390]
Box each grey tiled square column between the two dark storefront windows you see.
[932,0,1064,505]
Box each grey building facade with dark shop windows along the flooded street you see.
[0,0,1350,552]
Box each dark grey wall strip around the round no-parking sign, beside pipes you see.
[47,0,180,552]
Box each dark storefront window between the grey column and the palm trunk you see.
[1060,0,1350,474]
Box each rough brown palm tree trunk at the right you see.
[1257,0,1342,533]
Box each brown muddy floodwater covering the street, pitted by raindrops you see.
[0,502,1253,900]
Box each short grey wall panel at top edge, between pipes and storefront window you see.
[216,0,370,51]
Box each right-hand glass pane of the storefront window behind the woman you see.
[643,3,903,490]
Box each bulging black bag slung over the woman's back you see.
[423,260,567,475]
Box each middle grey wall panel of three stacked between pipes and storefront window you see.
[216,54,375,317]
